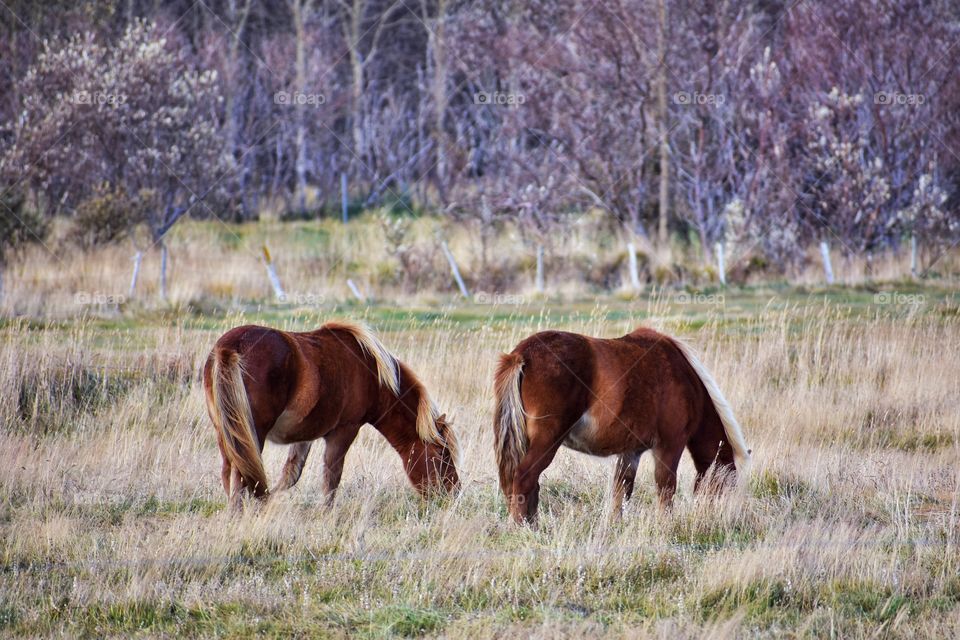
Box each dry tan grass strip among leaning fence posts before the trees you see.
[0,213,960,317]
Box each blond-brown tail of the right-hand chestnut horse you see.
[493,352,528,497]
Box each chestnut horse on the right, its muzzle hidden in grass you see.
[493,328,750,522]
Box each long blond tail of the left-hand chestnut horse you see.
[207,347,267,498]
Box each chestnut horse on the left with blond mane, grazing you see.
[203,322,459,508]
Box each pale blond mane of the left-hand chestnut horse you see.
[322,322,457,457]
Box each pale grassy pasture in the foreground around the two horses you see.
[0,288,960,637]
